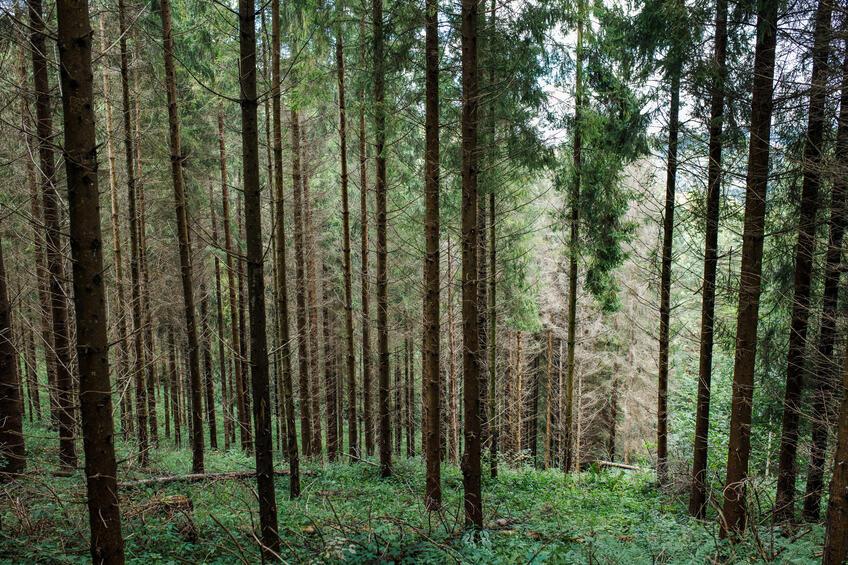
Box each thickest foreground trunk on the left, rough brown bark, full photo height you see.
[54,0,124,565]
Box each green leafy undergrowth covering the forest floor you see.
[0,428,823,564]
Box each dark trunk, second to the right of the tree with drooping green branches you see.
[688,0,727,519]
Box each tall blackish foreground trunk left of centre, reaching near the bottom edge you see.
[238,0,280,561]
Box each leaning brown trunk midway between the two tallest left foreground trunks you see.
[161,0,203,473]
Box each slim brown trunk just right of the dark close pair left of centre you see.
[291,110,313,455]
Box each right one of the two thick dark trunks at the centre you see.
[462,0,483,528]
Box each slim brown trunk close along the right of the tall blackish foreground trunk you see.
[271,0,300,499]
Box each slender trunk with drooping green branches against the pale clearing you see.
[562,0,583,474]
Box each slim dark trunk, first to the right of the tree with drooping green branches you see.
[657,49,681,486]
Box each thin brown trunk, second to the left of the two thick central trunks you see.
[358,9,374,455]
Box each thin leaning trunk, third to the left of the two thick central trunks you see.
[336,20,356,461]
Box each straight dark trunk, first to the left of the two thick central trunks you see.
[373,0,392,477]
